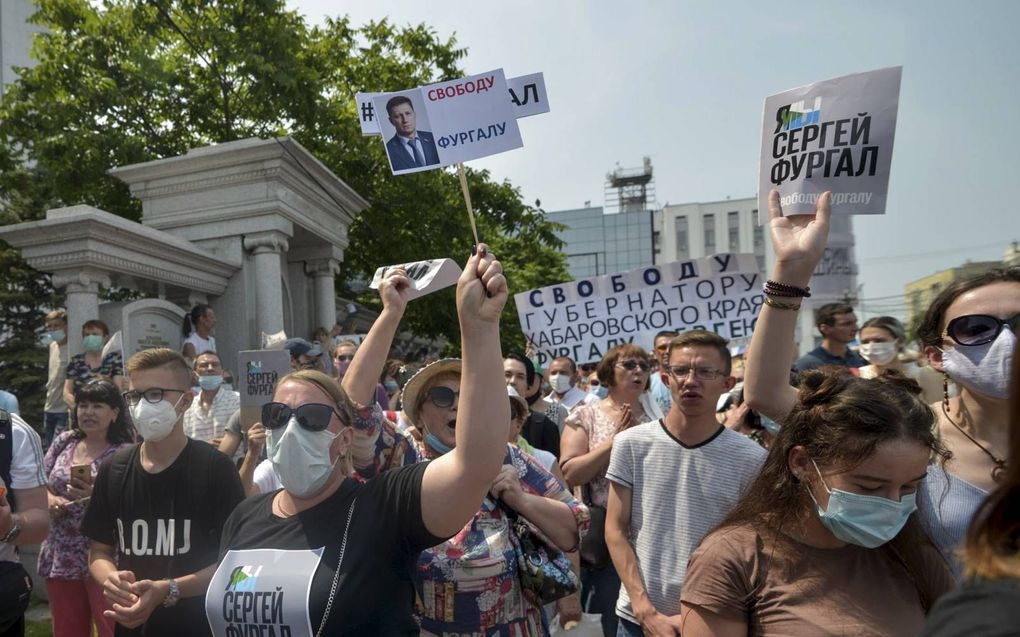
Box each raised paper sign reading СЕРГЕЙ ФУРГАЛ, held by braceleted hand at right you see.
[758,66,903,223]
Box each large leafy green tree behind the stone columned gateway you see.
[0,0,567,373]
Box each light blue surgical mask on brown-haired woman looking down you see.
[808,460,917,548]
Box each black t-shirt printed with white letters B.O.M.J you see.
[82,439,244,635]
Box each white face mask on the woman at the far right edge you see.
[942,329,1017,400]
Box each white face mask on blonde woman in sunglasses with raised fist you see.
[266,416,340,497]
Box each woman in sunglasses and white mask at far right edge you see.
[917,266,1020,575]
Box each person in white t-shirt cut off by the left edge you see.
[0,412,50,636]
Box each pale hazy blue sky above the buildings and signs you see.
[289,0,1020,314]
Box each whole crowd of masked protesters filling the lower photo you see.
[0,198,1020,637]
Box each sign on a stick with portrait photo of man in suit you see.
[372,68,524,174]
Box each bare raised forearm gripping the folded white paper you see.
[341,268,411,406]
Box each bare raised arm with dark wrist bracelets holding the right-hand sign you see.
[744,191,831,422]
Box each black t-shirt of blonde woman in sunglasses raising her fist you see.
[207,463,445,637]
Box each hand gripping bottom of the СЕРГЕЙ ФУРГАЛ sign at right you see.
[768,190,832,286]
